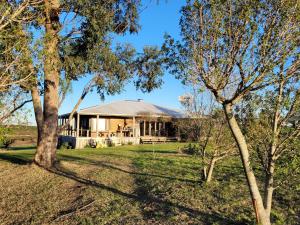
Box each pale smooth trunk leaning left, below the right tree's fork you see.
[223,104,271,225]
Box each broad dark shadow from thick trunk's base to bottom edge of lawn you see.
[48,164,237,224]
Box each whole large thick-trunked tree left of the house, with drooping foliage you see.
[0,0,162,168]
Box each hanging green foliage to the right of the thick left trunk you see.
[55,0,162,98]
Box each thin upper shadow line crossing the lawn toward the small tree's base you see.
[60,154,199,184]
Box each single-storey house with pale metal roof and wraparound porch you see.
[59,99,184,148]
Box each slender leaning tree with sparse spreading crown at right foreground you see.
[164,0,300,224]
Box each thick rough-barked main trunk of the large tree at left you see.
[35,0,60,168]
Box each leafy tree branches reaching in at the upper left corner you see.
[0,0,41,92]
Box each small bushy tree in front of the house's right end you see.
[178,90,236,183]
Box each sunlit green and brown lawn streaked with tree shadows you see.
[0,143,299,224]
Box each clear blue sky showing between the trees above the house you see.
[30,0,187,123]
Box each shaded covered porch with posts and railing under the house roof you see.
[58,113,178,138]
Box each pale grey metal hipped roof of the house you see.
[78,100,184,118]
